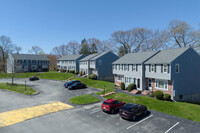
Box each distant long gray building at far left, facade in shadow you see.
[7,54,50,73]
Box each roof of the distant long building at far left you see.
[12,54,49,60]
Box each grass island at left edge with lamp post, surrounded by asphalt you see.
[0,83,38,95]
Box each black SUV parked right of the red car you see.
[119,103,147,120]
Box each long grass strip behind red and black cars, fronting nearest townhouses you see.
[106,93,200,122]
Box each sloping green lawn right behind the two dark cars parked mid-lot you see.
[73,77,115,95]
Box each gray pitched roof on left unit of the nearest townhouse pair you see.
[113,51,159,64]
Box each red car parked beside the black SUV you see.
[101,99,126,114]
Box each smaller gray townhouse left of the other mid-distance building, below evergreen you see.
[57,54,85,72]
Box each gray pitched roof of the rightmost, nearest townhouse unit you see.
[145,47,190,64]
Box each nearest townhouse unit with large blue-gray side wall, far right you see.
[145,47,200,103]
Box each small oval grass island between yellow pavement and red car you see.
[69,95,100,104]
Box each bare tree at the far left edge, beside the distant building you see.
[0,35,14,72]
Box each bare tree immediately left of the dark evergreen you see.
[67,41,80,55]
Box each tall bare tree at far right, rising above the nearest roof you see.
[168,20,200,48]
